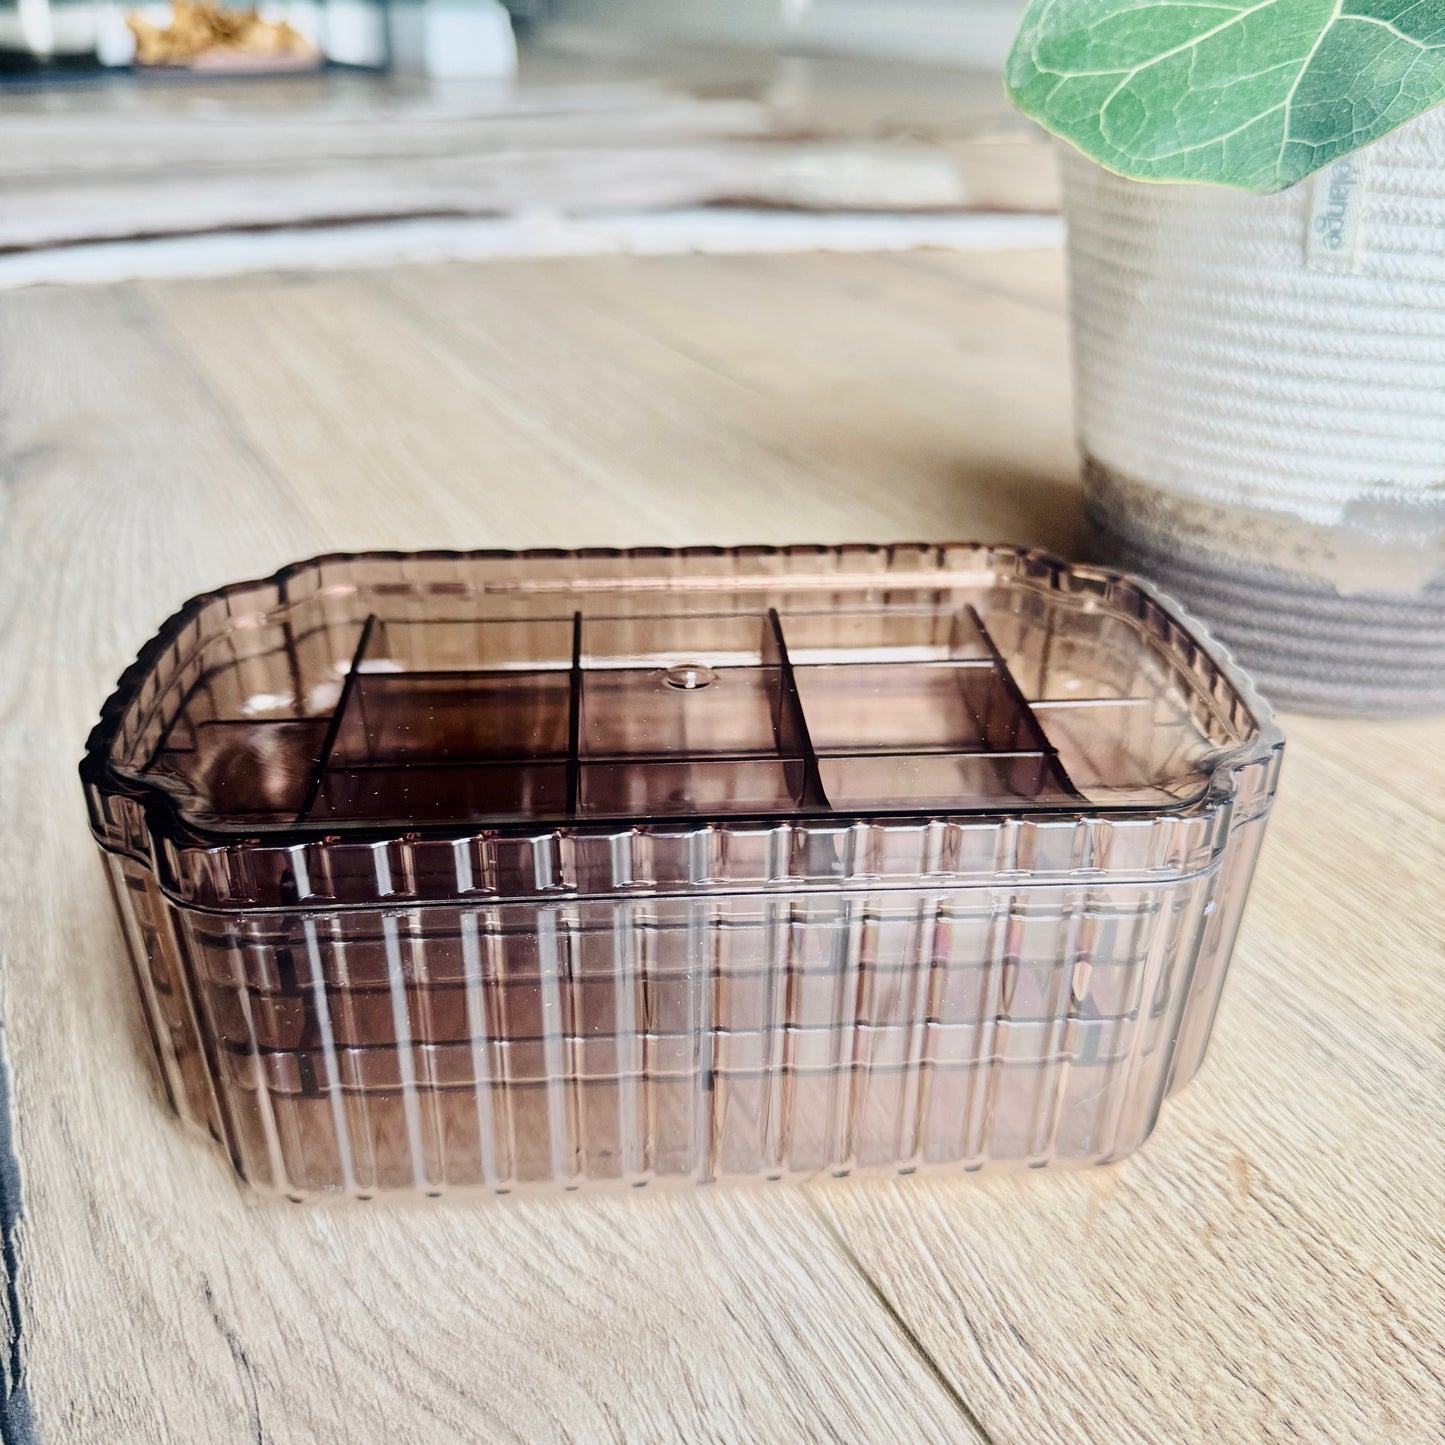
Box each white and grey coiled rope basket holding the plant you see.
[1064,100,1445,711]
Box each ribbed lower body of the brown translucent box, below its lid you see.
[106,829,1253,1198]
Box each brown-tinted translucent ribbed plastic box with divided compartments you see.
[81,546,1282,1198]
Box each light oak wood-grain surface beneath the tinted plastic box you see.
[0,254,1445,1445]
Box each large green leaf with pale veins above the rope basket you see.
[1004,0,1445,191]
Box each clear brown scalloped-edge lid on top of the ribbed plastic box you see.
[81,545,1280,906]
